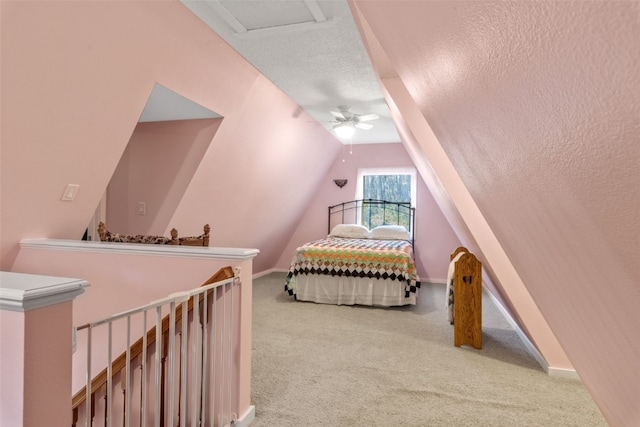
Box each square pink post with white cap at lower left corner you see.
[0,271,88,427]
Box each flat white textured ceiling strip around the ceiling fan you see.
[181,0,400,144]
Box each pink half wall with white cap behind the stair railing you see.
[14,243,253,411]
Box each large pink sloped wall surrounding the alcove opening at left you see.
[0,1,341,271]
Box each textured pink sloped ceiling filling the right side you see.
[353,1,640,425]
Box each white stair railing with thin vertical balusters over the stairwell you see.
[72,272,240,427]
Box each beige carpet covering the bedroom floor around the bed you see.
[251,273,607,427]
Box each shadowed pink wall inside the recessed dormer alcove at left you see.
[106,119,222,237]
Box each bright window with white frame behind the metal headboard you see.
[355,168,416,230]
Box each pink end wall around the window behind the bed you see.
[277,144,460,283]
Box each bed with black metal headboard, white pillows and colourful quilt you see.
[285,199,420,307]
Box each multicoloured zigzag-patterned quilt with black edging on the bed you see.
[285,237,420,297]
